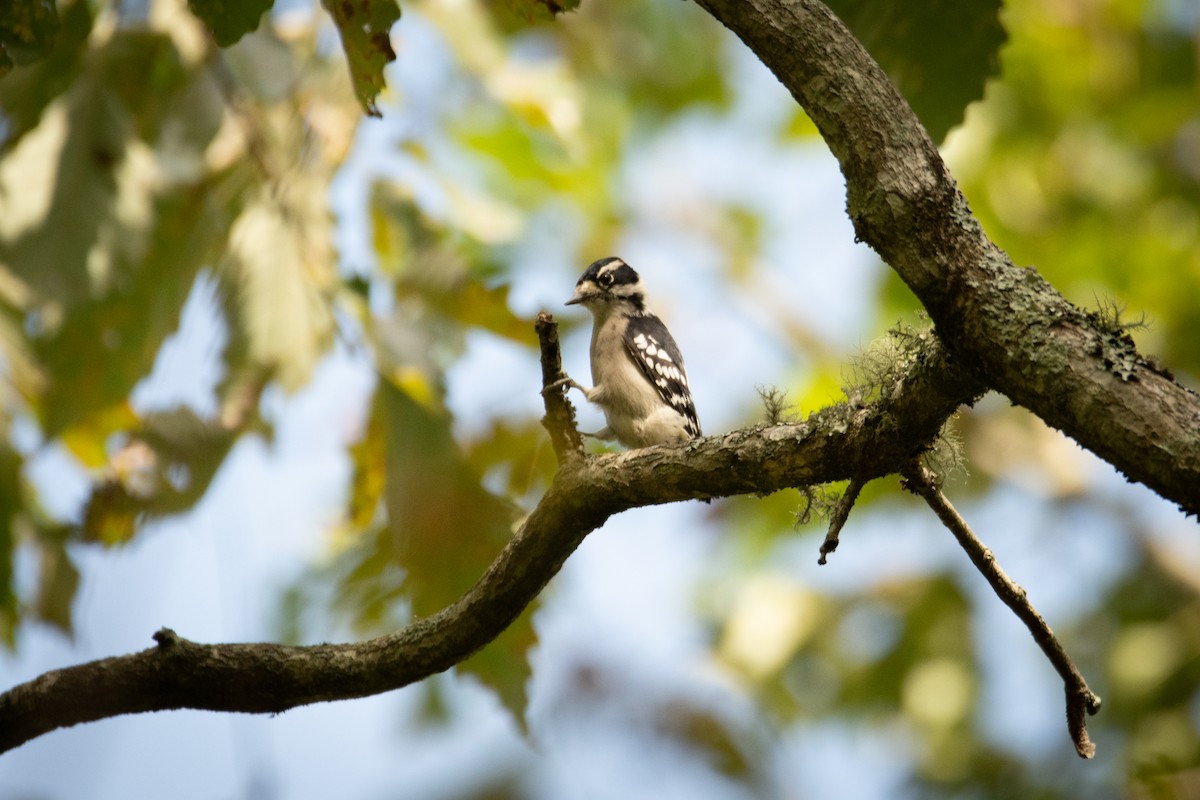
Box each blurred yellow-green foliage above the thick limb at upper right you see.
[888,0,1200,381]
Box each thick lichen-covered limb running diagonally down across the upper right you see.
[697,0,1200,513]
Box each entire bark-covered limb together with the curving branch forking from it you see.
[0,0,1200,750]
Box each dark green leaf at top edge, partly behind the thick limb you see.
[827,0,1006,142]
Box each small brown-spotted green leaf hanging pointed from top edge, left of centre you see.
[320,0,400,116]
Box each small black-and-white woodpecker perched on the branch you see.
[550,257,703,450]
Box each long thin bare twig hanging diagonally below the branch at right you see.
[901,462,1100,758]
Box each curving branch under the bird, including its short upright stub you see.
[0,315,980,752]
